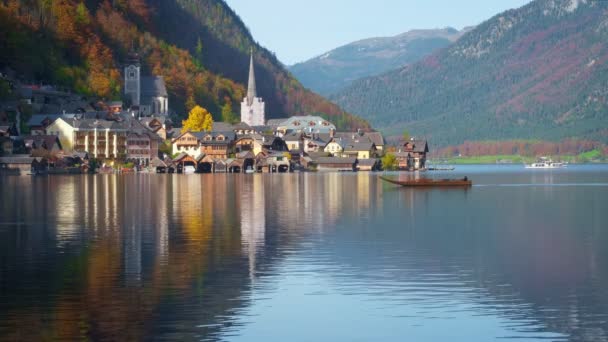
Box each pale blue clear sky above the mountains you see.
[226,0,530,64]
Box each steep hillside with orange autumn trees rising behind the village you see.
[0,0,369,129]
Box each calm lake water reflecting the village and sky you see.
[0,165,608,341]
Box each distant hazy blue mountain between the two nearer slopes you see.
[289,28,468,95]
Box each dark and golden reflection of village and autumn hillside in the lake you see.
[0,175,381,340]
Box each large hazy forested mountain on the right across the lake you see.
[332,0,608,146]
